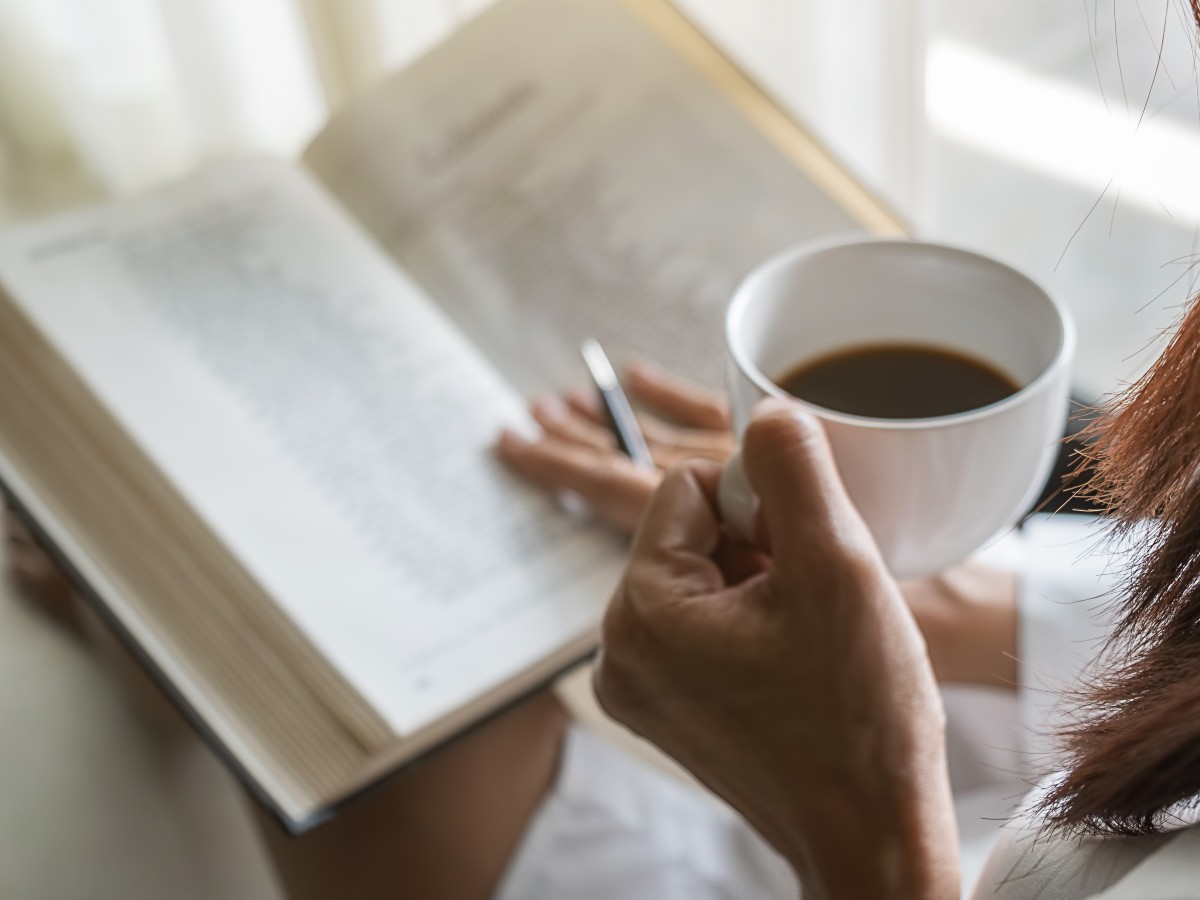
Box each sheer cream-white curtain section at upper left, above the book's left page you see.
[0,0,482,192]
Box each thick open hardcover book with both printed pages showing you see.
[0,0,896,830]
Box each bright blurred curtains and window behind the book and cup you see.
[0,0,1200,396]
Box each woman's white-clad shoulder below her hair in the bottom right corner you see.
[974,801,1200,900]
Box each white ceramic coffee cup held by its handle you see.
[719,236,1074,577]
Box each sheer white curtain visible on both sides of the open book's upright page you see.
[0,0,924,208]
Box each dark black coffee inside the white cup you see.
[775,343,1020,419]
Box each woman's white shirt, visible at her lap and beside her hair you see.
[496,516,1200,900]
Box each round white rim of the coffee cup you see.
[725,234,1075,431]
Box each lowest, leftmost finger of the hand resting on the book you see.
[496,431,659,532]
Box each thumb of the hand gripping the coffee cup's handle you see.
[742,398,866,564]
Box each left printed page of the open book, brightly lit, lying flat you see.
[0,161,622,734]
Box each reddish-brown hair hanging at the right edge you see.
[1042,31,1200,835]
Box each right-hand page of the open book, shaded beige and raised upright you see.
[305,0,858,392]
